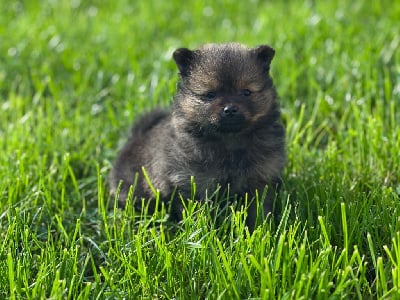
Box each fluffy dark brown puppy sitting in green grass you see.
[110,43,286,227]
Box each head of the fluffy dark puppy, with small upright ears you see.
[173,43,276,136]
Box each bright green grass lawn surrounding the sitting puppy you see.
[0,0,400,299]
